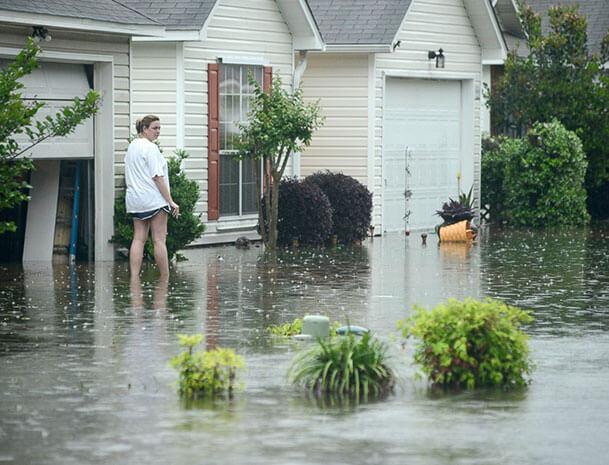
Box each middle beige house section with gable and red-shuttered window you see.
[116,0,323,244]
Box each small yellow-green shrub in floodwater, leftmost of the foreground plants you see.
[170,334,244,399]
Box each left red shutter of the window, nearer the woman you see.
[207,63,220,220]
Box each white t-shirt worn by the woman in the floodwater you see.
[125,137,169,213]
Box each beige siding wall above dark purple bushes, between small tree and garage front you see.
[300,53,368,185]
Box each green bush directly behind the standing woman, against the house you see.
[110,150,205,260]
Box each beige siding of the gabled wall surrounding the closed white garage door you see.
[373,0,482,226]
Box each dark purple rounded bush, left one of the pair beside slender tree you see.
[262,178,332,246]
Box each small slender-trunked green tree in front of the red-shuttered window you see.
[238,75,322,251]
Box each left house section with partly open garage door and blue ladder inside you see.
[0,0,164,262]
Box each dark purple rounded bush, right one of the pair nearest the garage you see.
[306,171,372,244]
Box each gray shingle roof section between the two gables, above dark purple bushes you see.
[307,0,411,45]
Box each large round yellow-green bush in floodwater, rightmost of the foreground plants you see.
[398,299,533,389]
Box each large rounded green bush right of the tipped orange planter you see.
[482,120,590,227]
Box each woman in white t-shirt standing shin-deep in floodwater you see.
[125,115,180,279]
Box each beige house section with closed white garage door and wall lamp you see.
[300,0,507,233]
